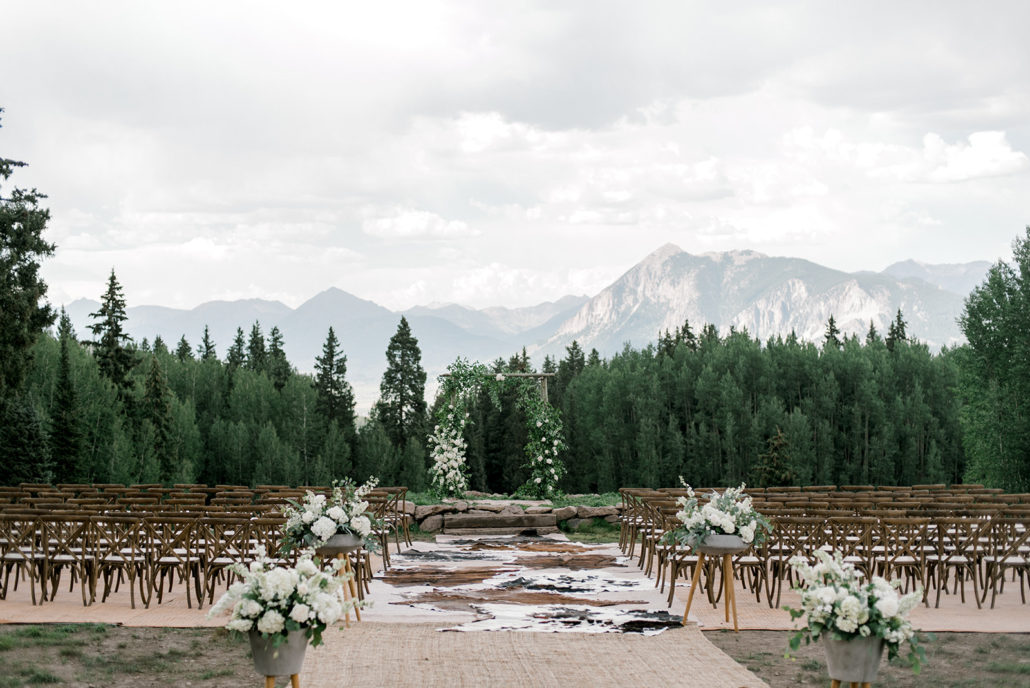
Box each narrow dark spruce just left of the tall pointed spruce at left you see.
[50,315,84,482]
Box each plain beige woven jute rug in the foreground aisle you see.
[301,621,766,688]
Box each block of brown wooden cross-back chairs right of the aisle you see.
[620,489,1030,607]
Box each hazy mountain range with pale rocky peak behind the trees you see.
[60,244,990,408]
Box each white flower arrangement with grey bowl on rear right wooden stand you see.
[665,478,773,554]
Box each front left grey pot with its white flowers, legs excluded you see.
[208,547,365,677]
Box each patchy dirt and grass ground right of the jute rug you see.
[705,630,1030,688]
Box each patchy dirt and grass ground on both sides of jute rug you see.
[0,624,1030,688]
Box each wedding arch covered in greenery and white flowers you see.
[428,358,565,497]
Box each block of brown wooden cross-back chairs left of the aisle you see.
[0,487,411,609]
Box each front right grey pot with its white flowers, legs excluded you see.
[785,550,926,683]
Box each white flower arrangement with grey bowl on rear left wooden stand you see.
[279,478,382,555]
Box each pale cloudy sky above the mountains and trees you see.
[0,0,1030,309]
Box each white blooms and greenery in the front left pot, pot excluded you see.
[208,546,367,646]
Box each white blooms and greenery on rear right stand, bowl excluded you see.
[674,478,769,545]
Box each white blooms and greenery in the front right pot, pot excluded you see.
[785,550,926,674]
